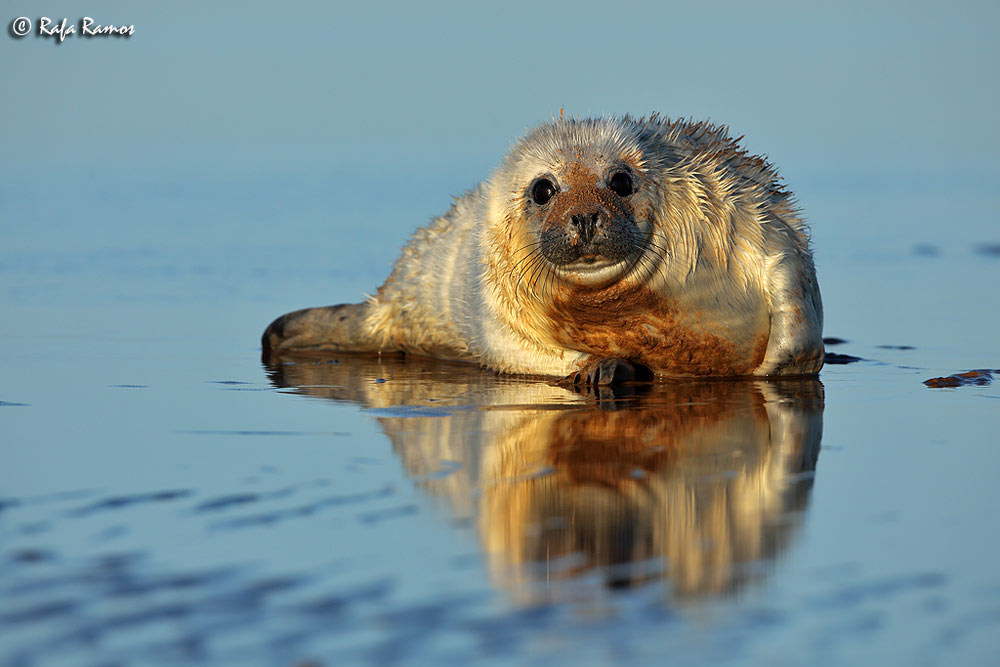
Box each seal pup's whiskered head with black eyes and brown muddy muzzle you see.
[490,119,651,288]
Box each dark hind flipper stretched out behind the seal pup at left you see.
[260,303,377,362]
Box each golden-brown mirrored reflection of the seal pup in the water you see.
[268,356,823,602]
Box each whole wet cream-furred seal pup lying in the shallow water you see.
[262,115,823,385]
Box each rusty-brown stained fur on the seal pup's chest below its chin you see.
[548,285,768,376]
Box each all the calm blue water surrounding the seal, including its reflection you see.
[0,3,1000,667]
